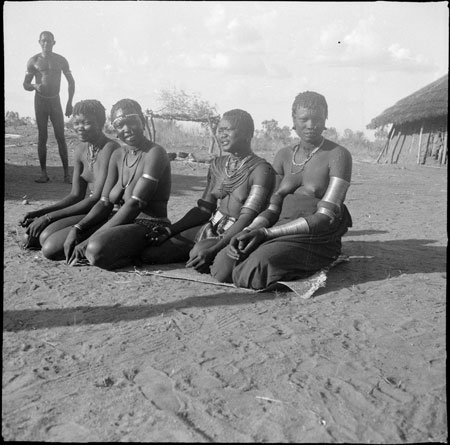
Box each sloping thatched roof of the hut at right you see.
[367,74,448,129]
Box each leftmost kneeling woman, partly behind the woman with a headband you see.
[20,100,119,255]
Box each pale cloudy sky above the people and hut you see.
[3,1,449,139]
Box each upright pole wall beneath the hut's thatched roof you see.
[377,119,447,165]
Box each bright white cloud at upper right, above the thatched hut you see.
[313,17,436,72]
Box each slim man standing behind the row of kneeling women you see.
[23,31,75,183]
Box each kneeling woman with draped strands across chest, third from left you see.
[141,110,275,273]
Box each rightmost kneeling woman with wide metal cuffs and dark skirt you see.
[211,91,352,289]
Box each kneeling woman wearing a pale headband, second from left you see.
[58,99,172,269]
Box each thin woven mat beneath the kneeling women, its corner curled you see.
[135,255,351,300]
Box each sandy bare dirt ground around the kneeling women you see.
[2,127,447,443]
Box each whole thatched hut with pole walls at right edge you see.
[367,74,448,165]
